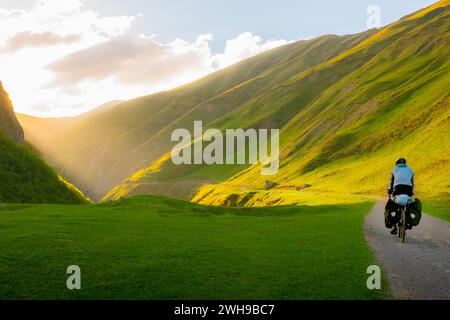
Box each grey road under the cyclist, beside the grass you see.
[364,201,450,300]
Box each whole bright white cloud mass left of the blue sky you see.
[0,0,287,116]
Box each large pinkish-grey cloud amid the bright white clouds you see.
[48,35,211,89]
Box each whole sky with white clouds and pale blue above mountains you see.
[0,0,435,117]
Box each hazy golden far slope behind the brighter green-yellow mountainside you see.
[24,31,374,199]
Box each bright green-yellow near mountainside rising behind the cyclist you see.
[105,1,450,205]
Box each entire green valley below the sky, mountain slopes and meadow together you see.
[0,0,450,300]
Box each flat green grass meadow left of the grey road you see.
[0,196,383,299]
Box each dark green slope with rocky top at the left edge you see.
[0,83,88,204]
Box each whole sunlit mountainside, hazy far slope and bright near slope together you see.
[15,1,450,205]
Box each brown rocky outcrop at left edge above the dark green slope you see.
[0,81,25,144]
